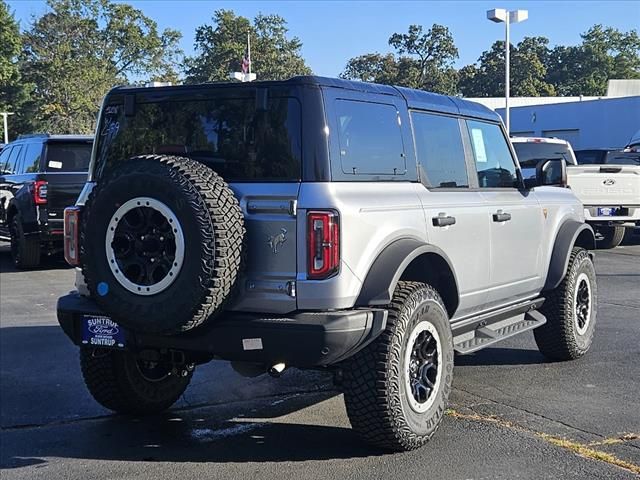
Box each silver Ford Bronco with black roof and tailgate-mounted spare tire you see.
[58,77,597,450]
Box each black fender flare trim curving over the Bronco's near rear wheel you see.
[356,238,458,305]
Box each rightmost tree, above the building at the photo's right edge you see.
[548,25,640,95]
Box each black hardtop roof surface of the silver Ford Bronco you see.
[112,75,500,122]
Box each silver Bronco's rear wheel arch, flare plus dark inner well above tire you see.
[356,238,460,318]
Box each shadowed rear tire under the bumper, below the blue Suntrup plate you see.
[80,348,193,415]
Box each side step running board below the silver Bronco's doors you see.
[452,298,547,354]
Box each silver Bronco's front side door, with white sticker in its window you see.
[466,120,544,306]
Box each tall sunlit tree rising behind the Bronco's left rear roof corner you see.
[22,0,181,133]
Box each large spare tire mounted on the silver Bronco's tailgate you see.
[80,155,245,334]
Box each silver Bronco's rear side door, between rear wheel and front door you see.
[411,111,490,317]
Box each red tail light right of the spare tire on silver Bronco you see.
[307,211,340,280]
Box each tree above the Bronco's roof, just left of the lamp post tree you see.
[340,24,458,94]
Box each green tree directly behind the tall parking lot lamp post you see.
[458,37,555,97]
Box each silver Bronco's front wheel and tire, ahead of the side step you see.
[533,247,598,361]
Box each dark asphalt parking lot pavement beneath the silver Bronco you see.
[0,240,640,480]
